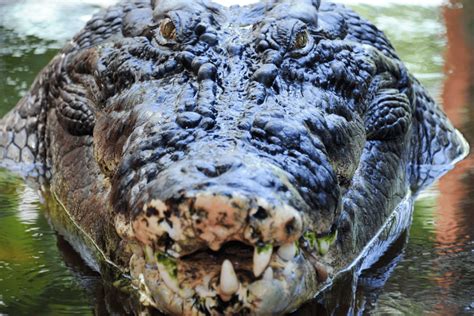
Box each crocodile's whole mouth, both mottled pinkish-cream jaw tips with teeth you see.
[115,193,335,315]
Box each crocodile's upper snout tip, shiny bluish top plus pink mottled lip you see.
[132,159,303,260]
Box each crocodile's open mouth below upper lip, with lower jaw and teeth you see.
[130,241,330,315]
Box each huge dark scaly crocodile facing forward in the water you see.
[0,0,468,315]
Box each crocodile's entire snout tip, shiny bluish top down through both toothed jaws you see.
[115,151,315,313]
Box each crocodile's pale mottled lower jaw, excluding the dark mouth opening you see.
[130,247,321,315]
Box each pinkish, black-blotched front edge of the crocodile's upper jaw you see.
[131,192,305,258]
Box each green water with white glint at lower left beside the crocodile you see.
[0,170,99,315]
